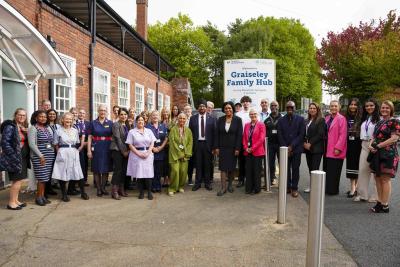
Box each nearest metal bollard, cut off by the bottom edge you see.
[306,171,326,267]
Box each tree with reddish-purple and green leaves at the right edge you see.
[317,11,400,99]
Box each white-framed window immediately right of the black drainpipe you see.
[93,68,110,118]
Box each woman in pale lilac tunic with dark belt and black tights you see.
[126,115,156,200]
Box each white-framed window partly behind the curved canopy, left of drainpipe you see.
[52,54,76,115]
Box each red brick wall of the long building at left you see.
[7,0,173,117]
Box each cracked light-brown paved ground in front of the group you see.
[0,175,356,267]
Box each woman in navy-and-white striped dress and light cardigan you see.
[28,110,55,206]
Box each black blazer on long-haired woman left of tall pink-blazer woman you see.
[304,118,326,154]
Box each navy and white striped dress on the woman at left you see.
[31,126,55,182]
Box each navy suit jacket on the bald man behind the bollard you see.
[277,114,305,153]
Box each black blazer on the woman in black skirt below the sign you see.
[215,115,243,151]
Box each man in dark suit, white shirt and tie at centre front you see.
[189,100,216,191]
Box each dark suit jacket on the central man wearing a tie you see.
[189,113,216,154]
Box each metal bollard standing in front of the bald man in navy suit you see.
[278,146,289,224]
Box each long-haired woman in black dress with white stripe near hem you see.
[346,98,362,198]
